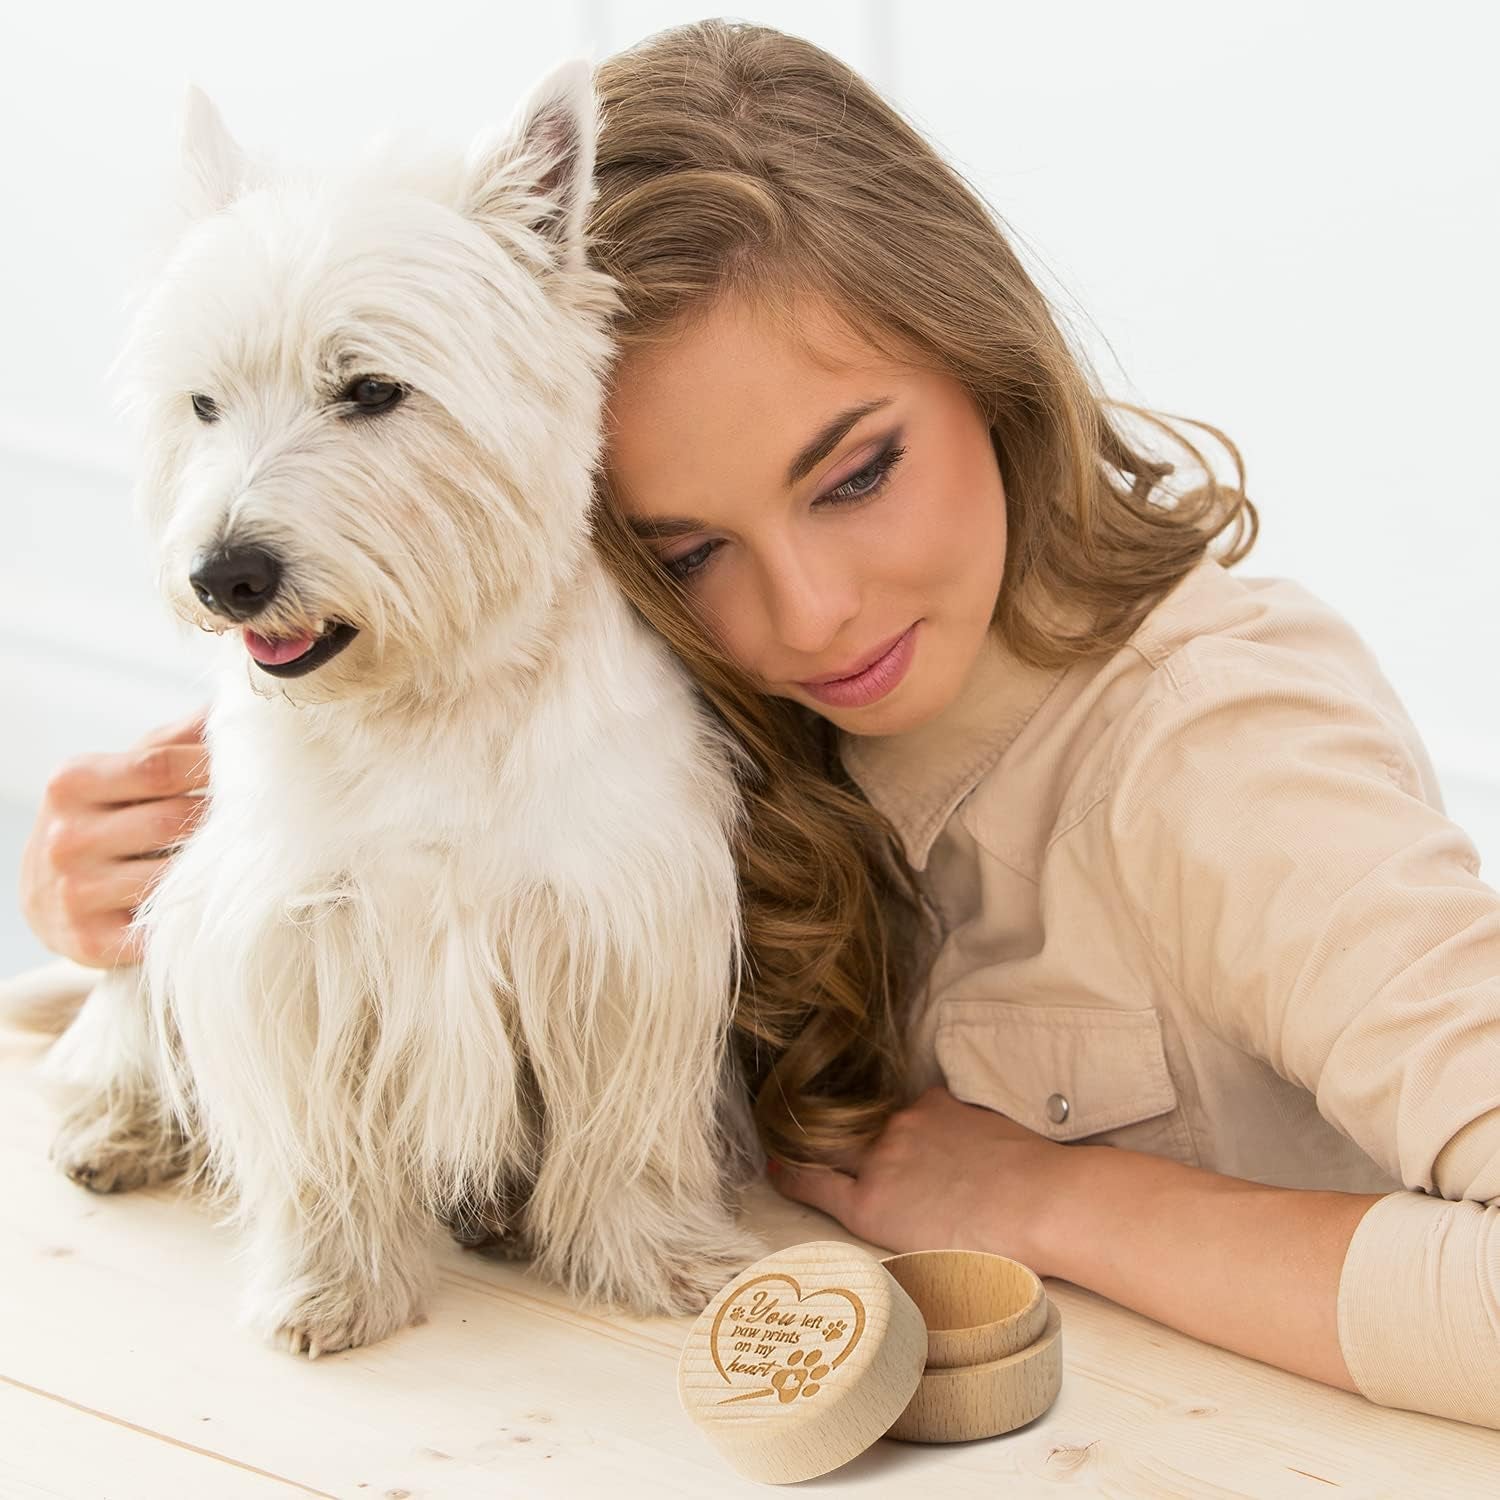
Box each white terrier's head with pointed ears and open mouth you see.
[113,60,617,701]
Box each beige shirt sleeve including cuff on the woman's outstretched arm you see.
[1100,638,1500,1428]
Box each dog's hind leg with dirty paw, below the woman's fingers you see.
[39,968,204,1193]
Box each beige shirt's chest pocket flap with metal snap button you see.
[933,999,1199,1166]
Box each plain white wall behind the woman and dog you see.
[0,0,1500,966]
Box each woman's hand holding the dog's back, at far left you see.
[21,710,209,969]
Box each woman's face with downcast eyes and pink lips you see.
[605,300,1005,735]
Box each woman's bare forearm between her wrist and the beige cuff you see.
[1034,1146,1380,1391]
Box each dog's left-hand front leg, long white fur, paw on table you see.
[149,876,440,1356]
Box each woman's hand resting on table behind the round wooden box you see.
[770,1083,1068,1275]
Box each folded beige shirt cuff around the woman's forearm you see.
[1338,1191,1500,1428]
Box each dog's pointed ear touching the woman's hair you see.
[464,57,599,270]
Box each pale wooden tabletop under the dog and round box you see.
[0,1029,1500,1500]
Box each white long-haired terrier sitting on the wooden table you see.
[44,62,765,1356]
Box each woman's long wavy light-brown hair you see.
[590,20,1257,1163]
